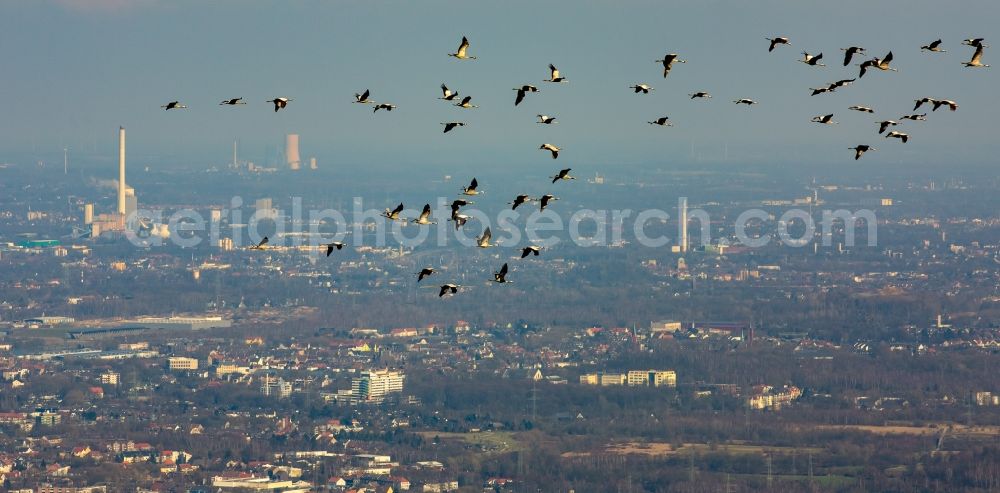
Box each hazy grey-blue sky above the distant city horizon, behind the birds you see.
[0,0,1000,166]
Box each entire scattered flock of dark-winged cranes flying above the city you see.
[161,36,989,297]
